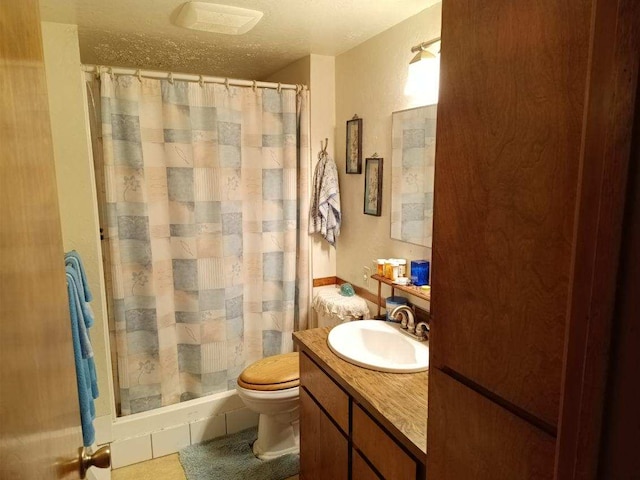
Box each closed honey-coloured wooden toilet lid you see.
[238,352,300,390]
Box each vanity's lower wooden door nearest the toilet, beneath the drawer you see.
[300,388,349,480]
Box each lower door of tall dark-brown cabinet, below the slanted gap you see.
[427,369,555,480]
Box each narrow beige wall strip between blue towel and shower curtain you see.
[42,22,113,417]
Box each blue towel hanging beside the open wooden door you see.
[65,258,99,447]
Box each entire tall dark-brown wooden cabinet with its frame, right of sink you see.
[428,0,640,480]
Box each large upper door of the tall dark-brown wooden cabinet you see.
[429,0,593,428]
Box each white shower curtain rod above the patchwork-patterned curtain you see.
[82,65,307,90]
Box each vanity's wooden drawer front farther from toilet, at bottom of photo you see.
[352,403,418,480]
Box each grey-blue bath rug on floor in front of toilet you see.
[180,427,300,480]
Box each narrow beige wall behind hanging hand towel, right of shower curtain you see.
[265,55,336,278]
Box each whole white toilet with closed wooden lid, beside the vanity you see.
[236,352,300,460]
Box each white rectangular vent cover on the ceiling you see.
[175,2,262,35]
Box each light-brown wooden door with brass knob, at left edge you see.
[0,0,82,480]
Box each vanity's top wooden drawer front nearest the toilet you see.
[300,353,349,435]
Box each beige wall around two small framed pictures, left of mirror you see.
[335,4,441,304]
